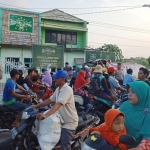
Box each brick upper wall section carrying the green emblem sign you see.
[0,8,41,45]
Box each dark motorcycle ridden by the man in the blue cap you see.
[0,106,99,150]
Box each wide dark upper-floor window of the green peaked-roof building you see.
[45,30,77,45]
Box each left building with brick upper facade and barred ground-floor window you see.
[0,7,41,83]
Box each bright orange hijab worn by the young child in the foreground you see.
[90,109,128,150]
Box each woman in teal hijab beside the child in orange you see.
[120,81,150,150]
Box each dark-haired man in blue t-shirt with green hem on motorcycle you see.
[2,69,30,126]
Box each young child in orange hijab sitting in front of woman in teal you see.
[81,109,128,150]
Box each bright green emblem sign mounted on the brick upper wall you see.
[9,14,33,33]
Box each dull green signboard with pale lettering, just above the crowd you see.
[32,45,64,68]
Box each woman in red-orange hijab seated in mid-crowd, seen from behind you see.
[74,70,91,110]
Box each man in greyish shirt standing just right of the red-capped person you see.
[115,63,124,85]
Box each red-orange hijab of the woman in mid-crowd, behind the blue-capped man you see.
[74,70,87,90]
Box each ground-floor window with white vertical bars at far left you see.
[5,57,19,74]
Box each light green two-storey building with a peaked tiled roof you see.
[40,9,88,66]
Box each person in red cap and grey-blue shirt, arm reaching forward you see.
[108,67,127,96]
